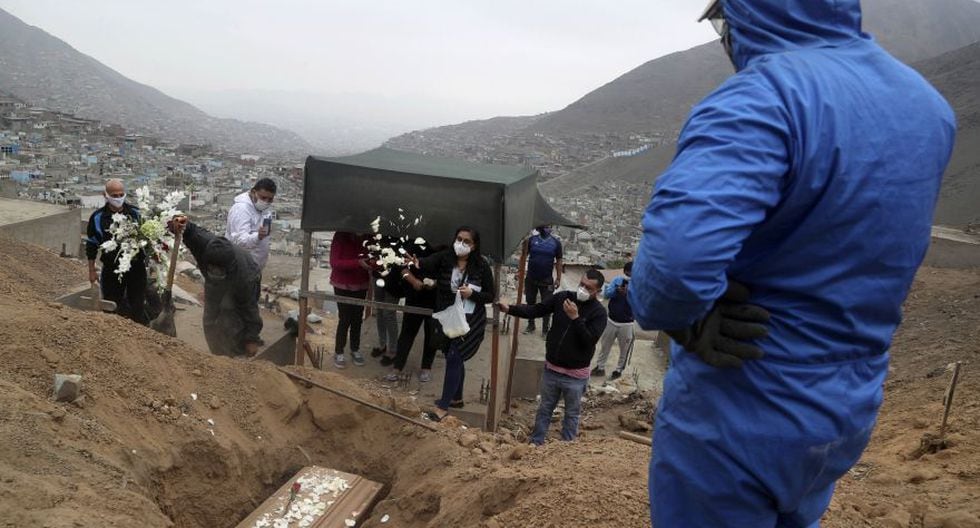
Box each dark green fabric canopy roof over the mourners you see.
[301,148,581,261]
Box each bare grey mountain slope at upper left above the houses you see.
[0,9,311,154]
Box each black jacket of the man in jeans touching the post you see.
[507,291,606,369]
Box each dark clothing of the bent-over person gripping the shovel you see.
[184,222,262,356]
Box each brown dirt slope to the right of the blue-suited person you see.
[824,268,980,528]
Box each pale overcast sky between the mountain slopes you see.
[0,0,716,118]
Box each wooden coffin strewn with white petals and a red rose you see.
[237,466,382,528]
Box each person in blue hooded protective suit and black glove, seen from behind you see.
[630,0,955,528]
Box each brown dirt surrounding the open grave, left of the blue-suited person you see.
[0,241,648,528]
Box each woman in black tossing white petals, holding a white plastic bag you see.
[402,226,496,421]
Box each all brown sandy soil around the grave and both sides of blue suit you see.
[0,236,980,528]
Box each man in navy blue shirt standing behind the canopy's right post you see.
[524,226,562,336]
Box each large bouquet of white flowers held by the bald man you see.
[101,187,184,289]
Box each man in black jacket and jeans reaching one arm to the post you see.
[497,269,606,445]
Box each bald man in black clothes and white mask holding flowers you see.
[85,179,149,325]
